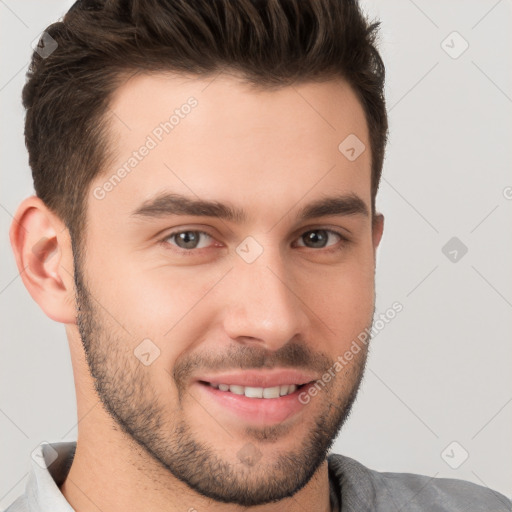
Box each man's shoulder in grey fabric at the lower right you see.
[328,454,512,512]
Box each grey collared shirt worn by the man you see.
[5,442,512,512]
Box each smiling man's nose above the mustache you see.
[223,251,309,350]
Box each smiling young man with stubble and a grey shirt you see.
[8,0,510,512]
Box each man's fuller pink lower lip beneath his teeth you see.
[195,382,310,424]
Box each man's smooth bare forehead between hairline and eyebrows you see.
[92,74,371,222]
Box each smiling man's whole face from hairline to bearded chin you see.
[76,75,382,506]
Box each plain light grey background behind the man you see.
[0,0,512,508]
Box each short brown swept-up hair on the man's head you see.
[23,0,388,250]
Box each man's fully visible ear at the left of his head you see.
[9,196,76,324]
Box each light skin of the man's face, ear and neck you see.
[11,74,383,512]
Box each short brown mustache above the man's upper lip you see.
[173,341,333,389]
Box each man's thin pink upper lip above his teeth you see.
[196,369,317,388]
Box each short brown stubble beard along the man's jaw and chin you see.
[75,262,372,507]
